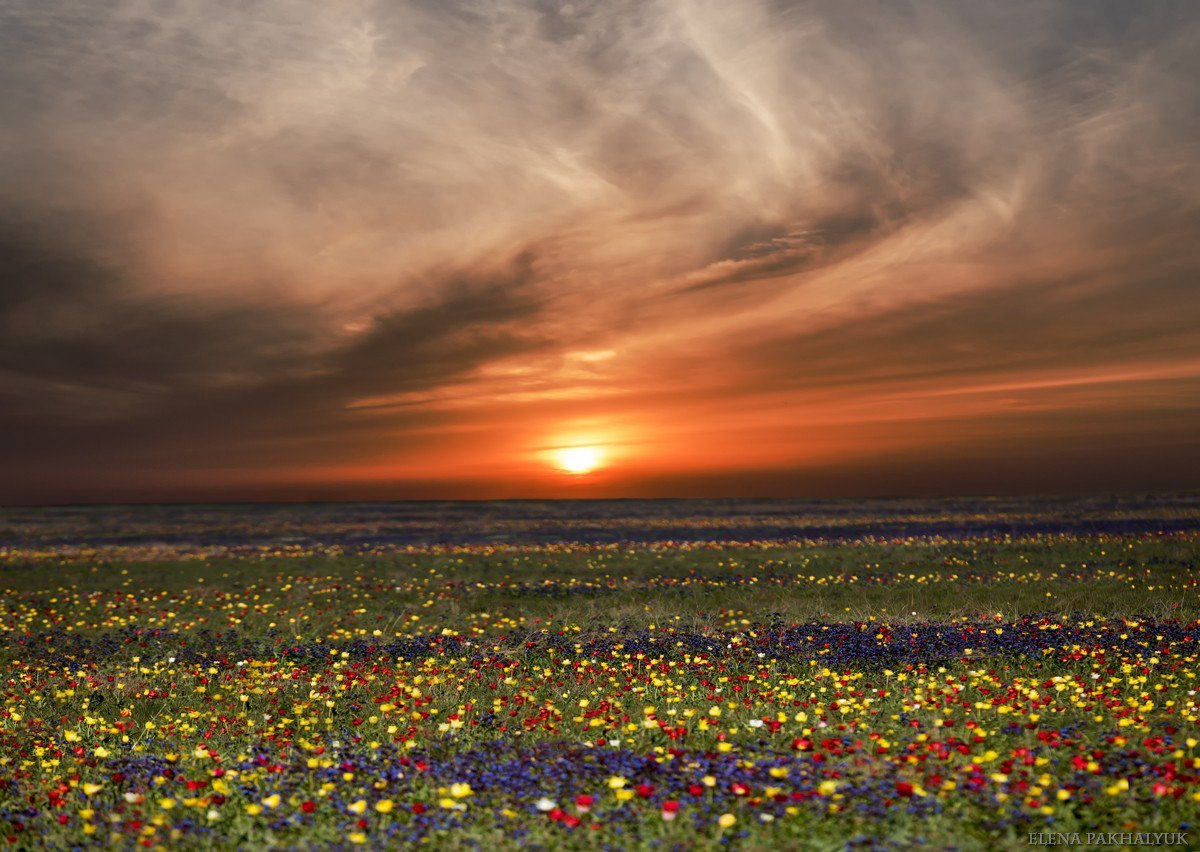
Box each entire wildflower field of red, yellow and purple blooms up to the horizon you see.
[0,498,1200,850]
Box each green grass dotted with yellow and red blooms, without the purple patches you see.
[0,535,1200,850]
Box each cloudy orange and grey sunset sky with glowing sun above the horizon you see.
[0,0,1200,504]
